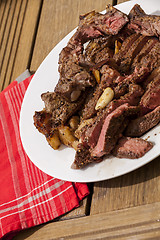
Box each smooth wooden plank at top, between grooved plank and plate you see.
[30,0,112,71]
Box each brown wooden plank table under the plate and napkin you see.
[0,0,160,240]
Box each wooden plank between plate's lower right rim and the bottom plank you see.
[90,157,160,215]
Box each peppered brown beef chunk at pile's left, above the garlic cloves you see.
[41,92,85,129]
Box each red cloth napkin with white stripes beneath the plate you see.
[0,76,89,239]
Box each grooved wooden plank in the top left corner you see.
[0,0,42,91]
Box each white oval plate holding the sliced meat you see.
[20,0,160,182]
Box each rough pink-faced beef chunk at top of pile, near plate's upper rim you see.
[95,7,129,35]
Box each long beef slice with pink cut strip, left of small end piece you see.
[91,104,139,157]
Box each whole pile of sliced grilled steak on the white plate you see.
[33,4,160,169]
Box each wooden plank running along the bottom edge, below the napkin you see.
[14,203,160,240]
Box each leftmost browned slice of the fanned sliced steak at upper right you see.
[113,33,140,65]
